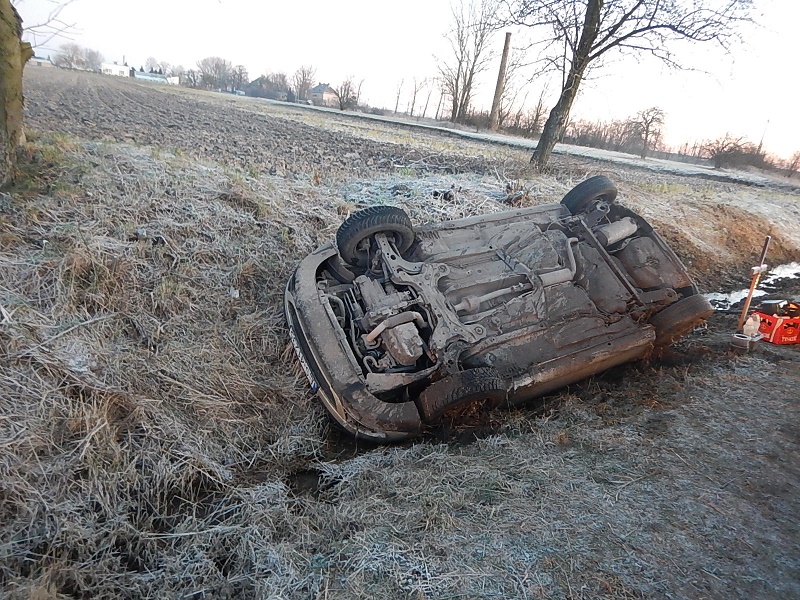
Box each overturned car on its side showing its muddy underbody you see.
[285,176,712,441]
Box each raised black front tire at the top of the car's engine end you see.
[336,206,414,268]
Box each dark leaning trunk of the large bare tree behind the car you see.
[531,0,603,170]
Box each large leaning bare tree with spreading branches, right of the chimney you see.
[505,0,751,169]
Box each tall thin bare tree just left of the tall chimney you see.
[439,0,496,123]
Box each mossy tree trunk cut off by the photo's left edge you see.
[0,0,33,187]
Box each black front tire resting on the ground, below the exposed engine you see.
[417,367,507,424]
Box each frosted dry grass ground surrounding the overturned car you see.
[0,68,800,599]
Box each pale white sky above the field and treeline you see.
[15,0,800,158]
